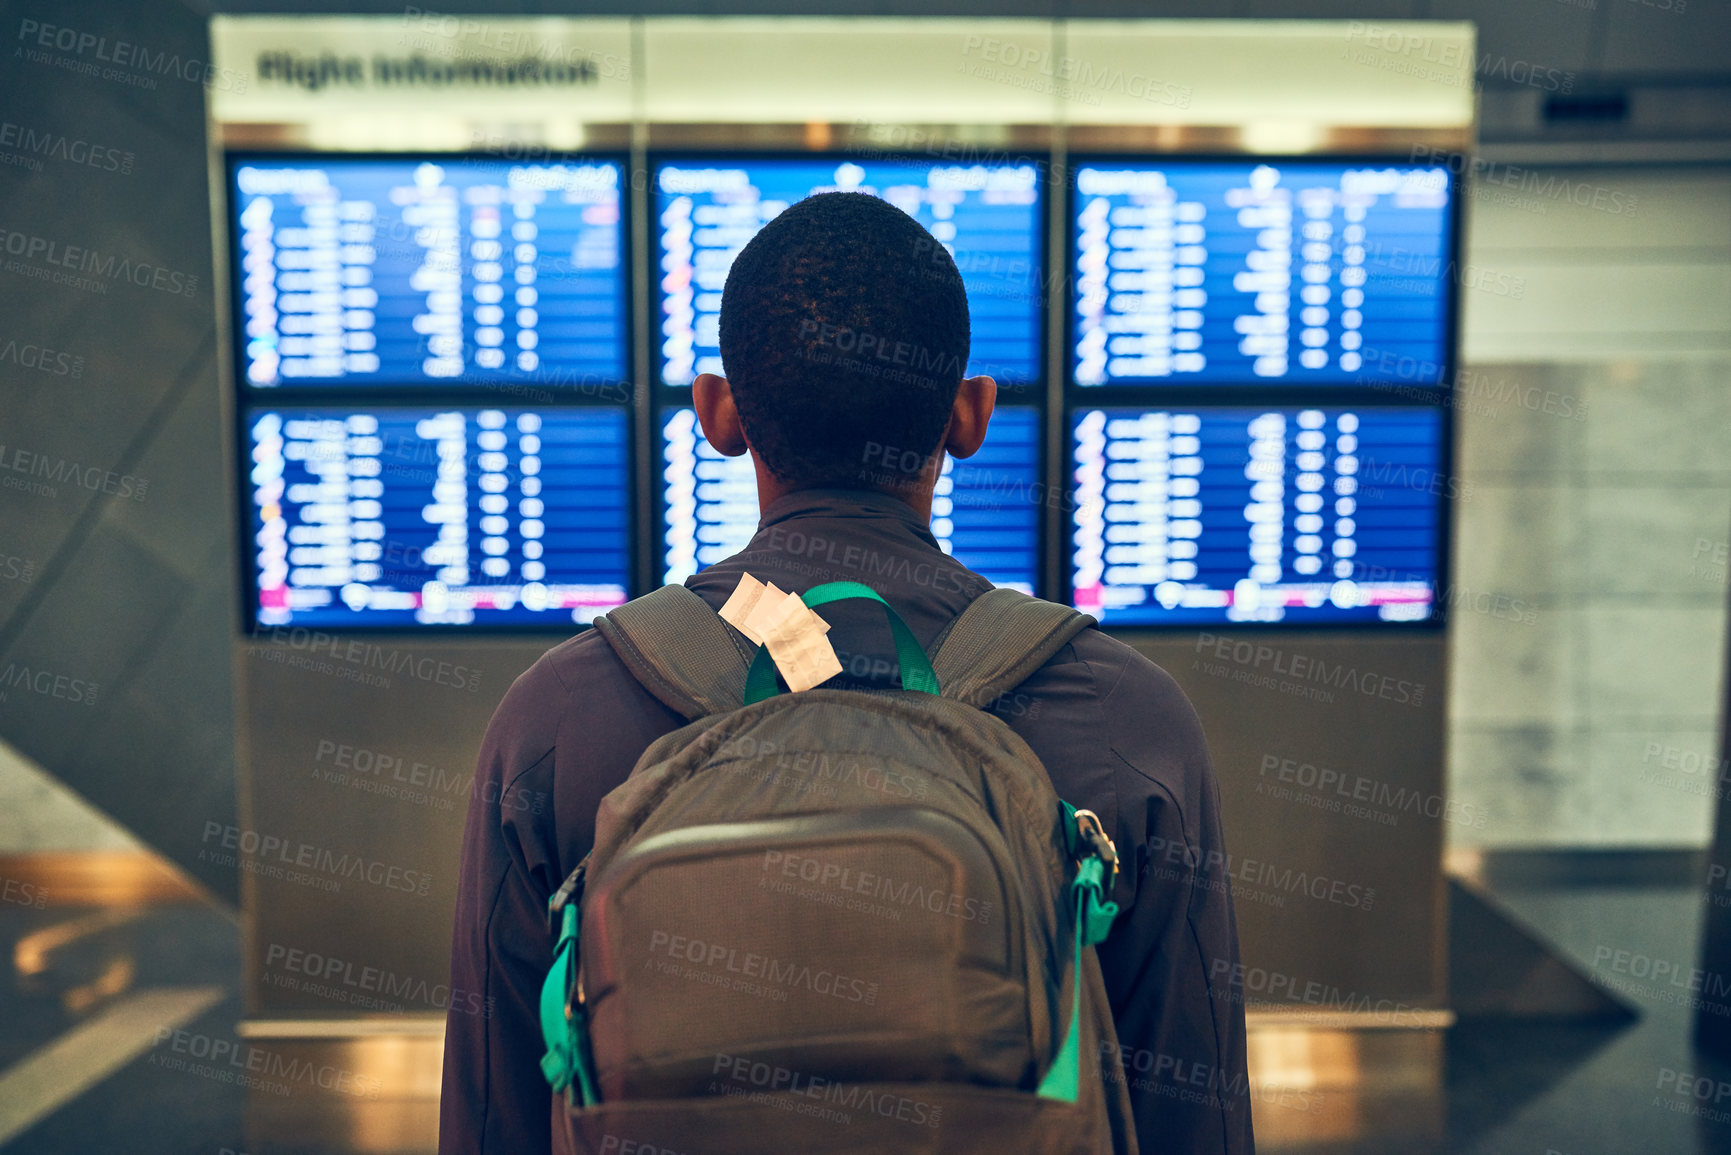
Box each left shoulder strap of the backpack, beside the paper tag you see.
[595,585,755,720]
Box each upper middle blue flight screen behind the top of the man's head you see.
[654,158,1044,386]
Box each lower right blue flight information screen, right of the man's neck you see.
[1071,407,1454,625]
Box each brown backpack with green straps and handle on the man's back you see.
[540,582,1136,1155]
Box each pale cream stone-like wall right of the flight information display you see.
[1449,166,1731,849]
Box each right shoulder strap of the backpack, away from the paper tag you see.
[931,589,1096,710]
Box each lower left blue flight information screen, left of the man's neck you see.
[246,407,630,629]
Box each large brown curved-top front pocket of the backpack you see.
[582,807,1035,1101]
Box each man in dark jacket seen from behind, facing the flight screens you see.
[440,192,1252,1155]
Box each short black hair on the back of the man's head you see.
[720,192,971,490]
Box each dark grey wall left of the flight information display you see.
[0,0,239,900]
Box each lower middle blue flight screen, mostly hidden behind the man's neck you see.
[661,405,1046,594]
